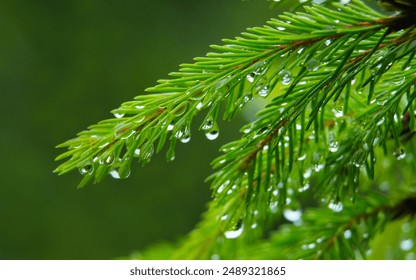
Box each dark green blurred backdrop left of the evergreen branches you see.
[0,0,276,259]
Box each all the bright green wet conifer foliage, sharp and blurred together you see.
[56,1,416,259]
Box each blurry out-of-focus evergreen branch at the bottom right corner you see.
[245,194,416,259]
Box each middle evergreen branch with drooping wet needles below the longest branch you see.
[210,12,415,242]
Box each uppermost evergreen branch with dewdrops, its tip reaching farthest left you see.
[55,0,394,186]
